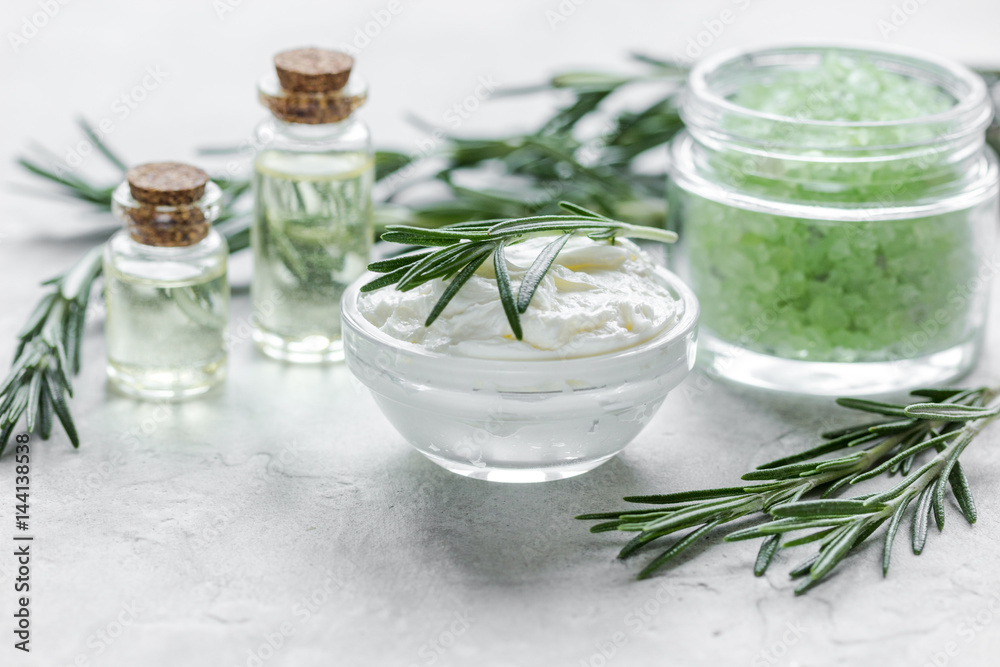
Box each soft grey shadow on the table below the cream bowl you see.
[364,452,660,583]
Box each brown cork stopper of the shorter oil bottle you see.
[115,162,218,247]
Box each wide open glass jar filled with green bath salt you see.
[669,46,998,395]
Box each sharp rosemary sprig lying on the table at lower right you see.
[577,387,1000,594]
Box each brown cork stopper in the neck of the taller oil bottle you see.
[259,48,368,125]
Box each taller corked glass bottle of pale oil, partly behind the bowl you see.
[251,49,374,363]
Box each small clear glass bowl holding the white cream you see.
[341,267,698,482]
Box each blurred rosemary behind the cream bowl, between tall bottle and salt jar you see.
[381,55,687,226]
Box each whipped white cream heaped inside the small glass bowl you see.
[358,237,682,360]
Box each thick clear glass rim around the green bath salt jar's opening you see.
[682,41,993,149]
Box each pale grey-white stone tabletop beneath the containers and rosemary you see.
[0,0,1000,667]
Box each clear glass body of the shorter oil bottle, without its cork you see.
[104,183,229,400]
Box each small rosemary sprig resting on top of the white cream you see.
[361,202,677,340]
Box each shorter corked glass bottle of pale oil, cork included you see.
[104,162,229,399]
